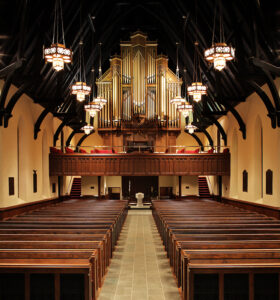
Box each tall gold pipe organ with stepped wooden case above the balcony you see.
[96,32,182,132]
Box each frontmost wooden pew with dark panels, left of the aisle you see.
[0,249,98,300]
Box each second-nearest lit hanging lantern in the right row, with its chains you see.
[188,41,207,102]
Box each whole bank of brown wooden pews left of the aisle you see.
[0,200,127,300]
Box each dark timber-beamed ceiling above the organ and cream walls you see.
[0,0,280,131]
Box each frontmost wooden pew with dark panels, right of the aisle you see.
[182,249,280,300]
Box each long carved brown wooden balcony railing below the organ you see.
[50,153,230,176]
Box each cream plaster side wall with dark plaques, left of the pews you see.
[0,81,72,207]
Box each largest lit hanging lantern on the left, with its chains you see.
[43,0,72,71]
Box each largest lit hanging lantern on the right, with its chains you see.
[204,2,235,71]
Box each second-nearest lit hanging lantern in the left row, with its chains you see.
[71,41,91,102]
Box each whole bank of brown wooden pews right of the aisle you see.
[153,200,280,300]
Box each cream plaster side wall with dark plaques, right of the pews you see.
[219,78,280,206]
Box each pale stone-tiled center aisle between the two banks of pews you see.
[98,210,180,300]
